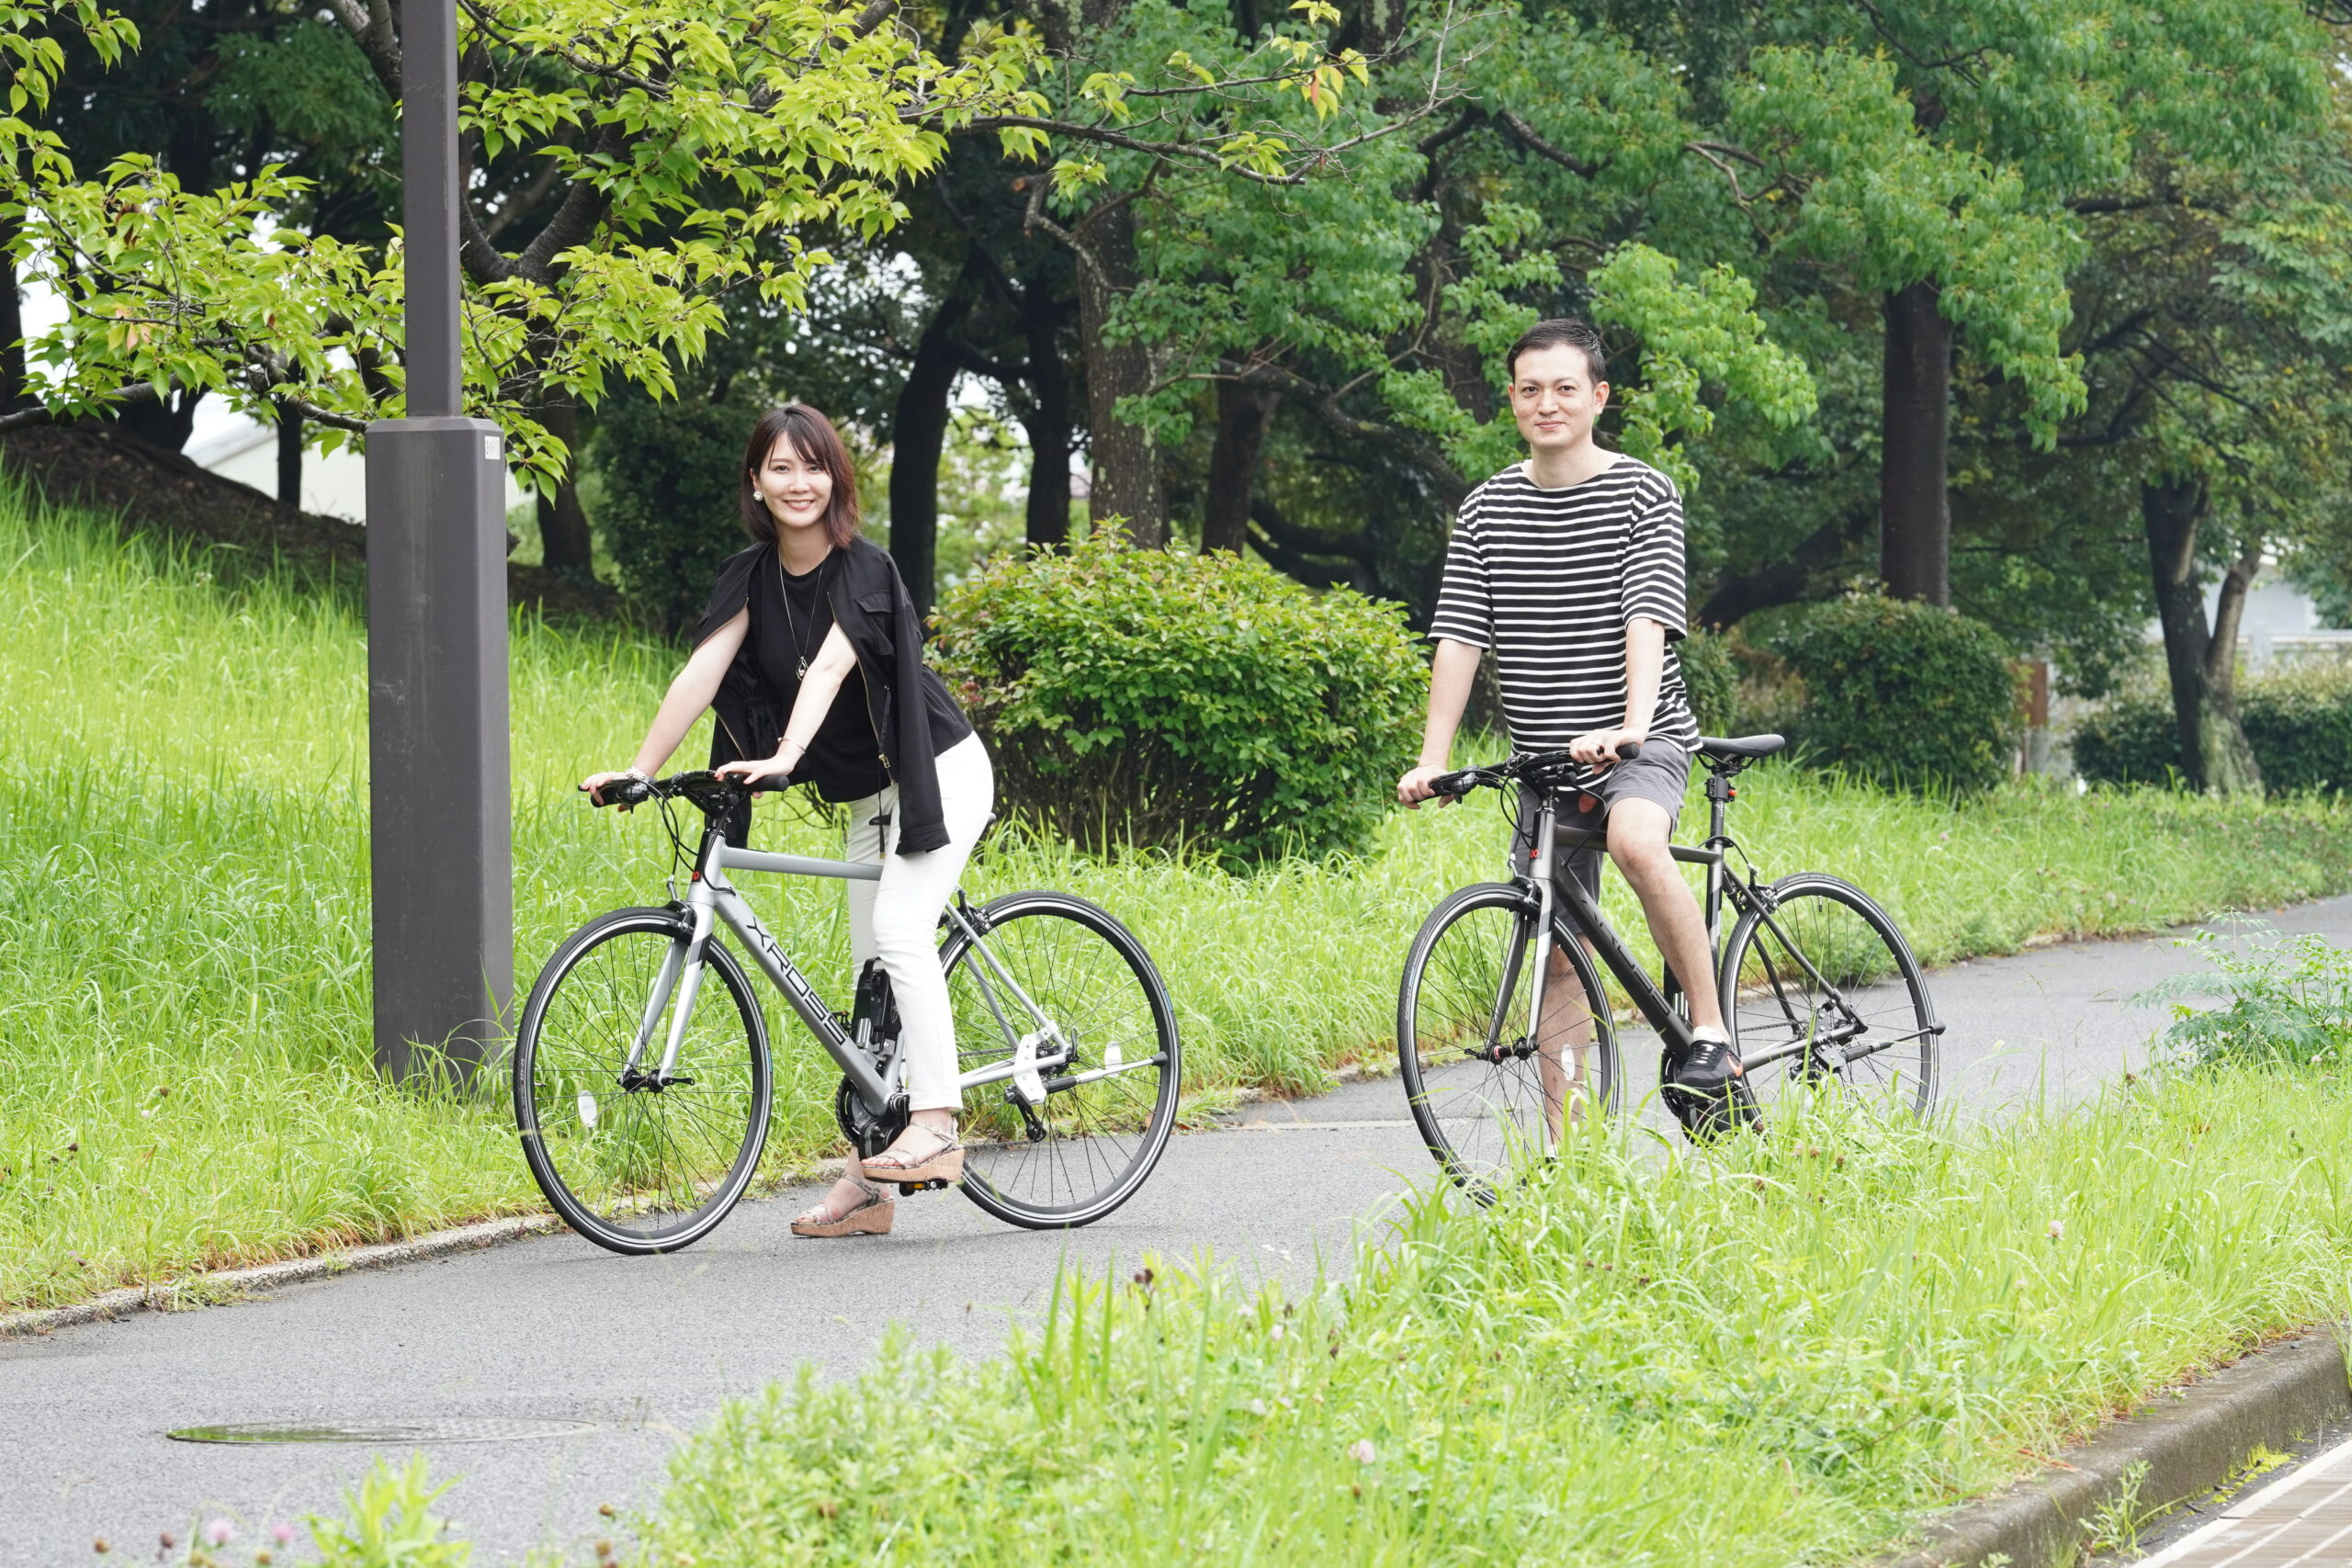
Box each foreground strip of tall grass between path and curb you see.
[633,1067,2352,1568]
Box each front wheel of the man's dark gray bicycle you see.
[1397,882,1618,1203]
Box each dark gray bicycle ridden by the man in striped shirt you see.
[1397,736,1943,1199]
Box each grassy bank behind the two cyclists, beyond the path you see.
[14,491,2352,1304]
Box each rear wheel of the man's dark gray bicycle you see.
[1719,872,1943,1126]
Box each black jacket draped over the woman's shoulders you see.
[694,538,959,853]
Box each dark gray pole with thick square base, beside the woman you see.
[367,0,515,1079]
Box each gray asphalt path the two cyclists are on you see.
[0,898,2352,1568]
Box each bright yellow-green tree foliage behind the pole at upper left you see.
[0,0,1042,564]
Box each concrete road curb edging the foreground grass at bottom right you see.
[1884,1325,2352,1568]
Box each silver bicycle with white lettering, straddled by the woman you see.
[515,771,1183,1253]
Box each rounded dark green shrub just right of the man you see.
[1776,597,2018,792]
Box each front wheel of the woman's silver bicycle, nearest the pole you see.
[515,909,772,1256]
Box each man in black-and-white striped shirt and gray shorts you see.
[1397,320,1740,1128]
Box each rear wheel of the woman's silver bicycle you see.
[941,894,1183,1229]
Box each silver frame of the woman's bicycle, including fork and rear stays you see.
[623,828,1077,1112]
